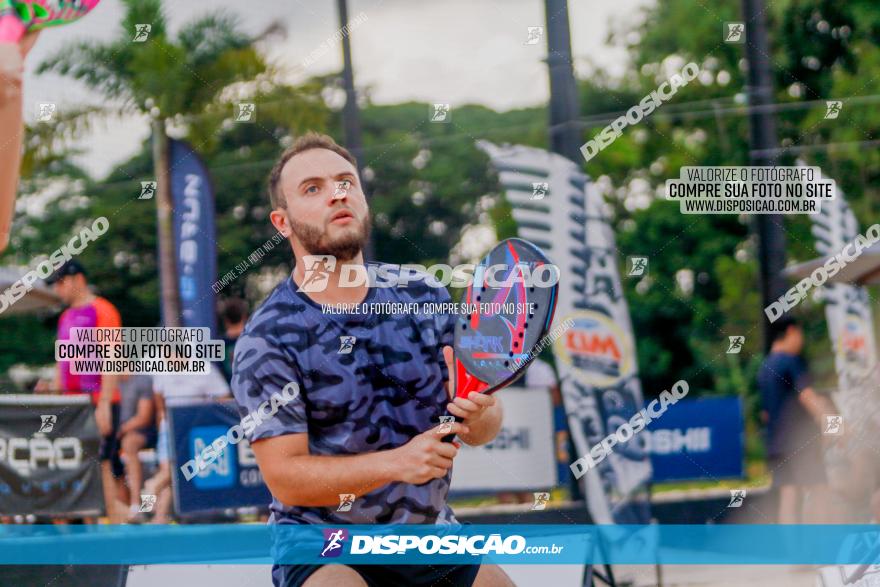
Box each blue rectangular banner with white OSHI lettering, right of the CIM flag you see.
[641,397,744,483]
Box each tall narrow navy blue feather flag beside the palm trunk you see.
[168,139,217,338]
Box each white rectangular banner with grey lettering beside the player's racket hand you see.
[450,387,556,492]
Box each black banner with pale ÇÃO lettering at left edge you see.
[0,395,104,517]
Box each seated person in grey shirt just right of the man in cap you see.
[117,375,157,522]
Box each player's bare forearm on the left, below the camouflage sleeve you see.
[267,450,397,507]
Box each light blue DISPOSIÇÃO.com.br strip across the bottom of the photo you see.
[0,524,880,565]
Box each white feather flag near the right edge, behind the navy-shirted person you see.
[811,168,880,438]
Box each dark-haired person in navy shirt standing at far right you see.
[758,316,840,524]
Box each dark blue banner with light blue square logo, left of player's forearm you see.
[168,401,272,515]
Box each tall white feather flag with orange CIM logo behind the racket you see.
[478,141,651,524]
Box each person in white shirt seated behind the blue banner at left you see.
[144,365,232,524]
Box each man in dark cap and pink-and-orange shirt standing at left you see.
[46,259,125,522]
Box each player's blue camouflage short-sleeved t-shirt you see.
[232,264,455,524]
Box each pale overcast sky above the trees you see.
[25,0,652,177]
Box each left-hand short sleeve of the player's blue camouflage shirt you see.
[232,333,308,442]
